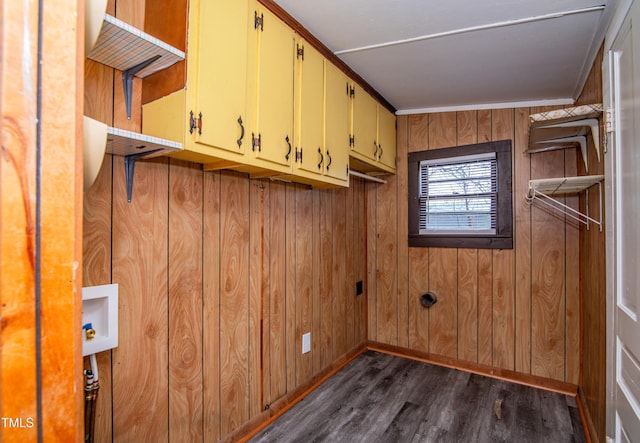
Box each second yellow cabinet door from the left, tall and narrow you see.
[252,8,294,169]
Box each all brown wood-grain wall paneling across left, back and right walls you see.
[83,0,604,441]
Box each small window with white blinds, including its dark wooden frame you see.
[409,140,513,249]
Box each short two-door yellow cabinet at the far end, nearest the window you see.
[349,84,396,173]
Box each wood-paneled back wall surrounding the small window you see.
[367,108,580,384]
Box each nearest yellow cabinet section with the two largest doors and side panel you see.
[143,0,294,176]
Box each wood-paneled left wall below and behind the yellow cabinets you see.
[84,0,366,442]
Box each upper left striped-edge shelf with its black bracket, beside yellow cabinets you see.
[86,14,184,119]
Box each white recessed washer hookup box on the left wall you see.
[81,284,118,356]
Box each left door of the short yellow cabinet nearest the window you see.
[351,86,378,160]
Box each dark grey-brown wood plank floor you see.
[249,351,585,443]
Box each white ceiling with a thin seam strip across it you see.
[275,0,616,113]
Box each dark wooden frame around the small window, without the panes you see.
[408,140,513,249]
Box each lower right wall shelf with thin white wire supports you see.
[525,175,604,231]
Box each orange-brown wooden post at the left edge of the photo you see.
[0,0,84,442]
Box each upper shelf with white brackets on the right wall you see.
[526,103,603,171]
